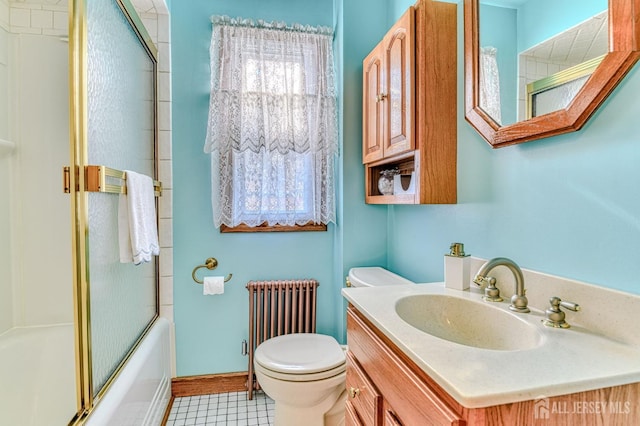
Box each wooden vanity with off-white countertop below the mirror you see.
[343,283,640,426]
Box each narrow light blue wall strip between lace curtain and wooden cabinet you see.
[336,0,390,342]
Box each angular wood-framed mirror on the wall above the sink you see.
[464,0,640,148]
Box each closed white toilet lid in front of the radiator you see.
[254,333,346,374]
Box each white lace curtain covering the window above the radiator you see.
[204,16,338,227]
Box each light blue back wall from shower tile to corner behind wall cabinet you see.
[171,0,387,376]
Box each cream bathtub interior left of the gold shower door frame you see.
[0,324,76,426]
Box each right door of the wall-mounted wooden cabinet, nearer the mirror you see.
[381,7,415,157]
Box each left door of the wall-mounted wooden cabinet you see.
[362,45,384,164]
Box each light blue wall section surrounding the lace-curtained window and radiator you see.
[171,0,342,376]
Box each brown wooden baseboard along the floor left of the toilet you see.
[171,371,248,397]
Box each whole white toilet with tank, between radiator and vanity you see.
[253,267,413,426]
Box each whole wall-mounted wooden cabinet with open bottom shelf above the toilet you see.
[362,0,457,204]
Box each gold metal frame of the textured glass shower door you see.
[68,0,160,425]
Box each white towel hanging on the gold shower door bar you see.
[118,170,160,265]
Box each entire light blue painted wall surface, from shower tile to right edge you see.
[171,0,640,376]
